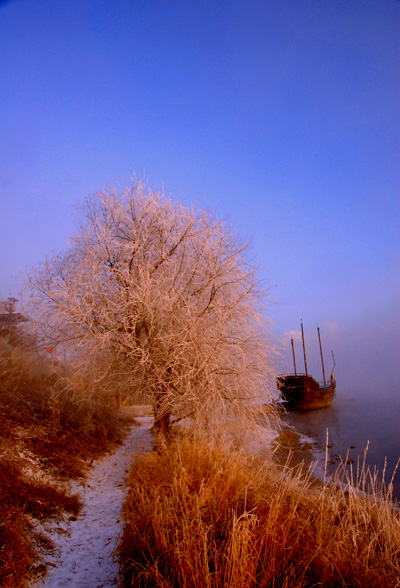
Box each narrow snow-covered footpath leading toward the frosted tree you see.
[34,418,153,588]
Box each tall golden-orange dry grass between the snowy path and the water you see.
[119,439,400,588]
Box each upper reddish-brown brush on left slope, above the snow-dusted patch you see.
[0,338,128,477]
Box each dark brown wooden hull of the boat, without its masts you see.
[276,374,336,411]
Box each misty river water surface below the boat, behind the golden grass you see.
[283,396,400,500]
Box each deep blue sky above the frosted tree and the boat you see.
[0,0,400,385]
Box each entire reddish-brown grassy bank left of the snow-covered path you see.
[0,334,133,588]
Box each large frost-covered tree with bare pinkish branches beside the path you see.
[25,181,271,436]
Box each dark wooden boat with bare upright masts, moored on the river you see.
[276,323,336,410]
